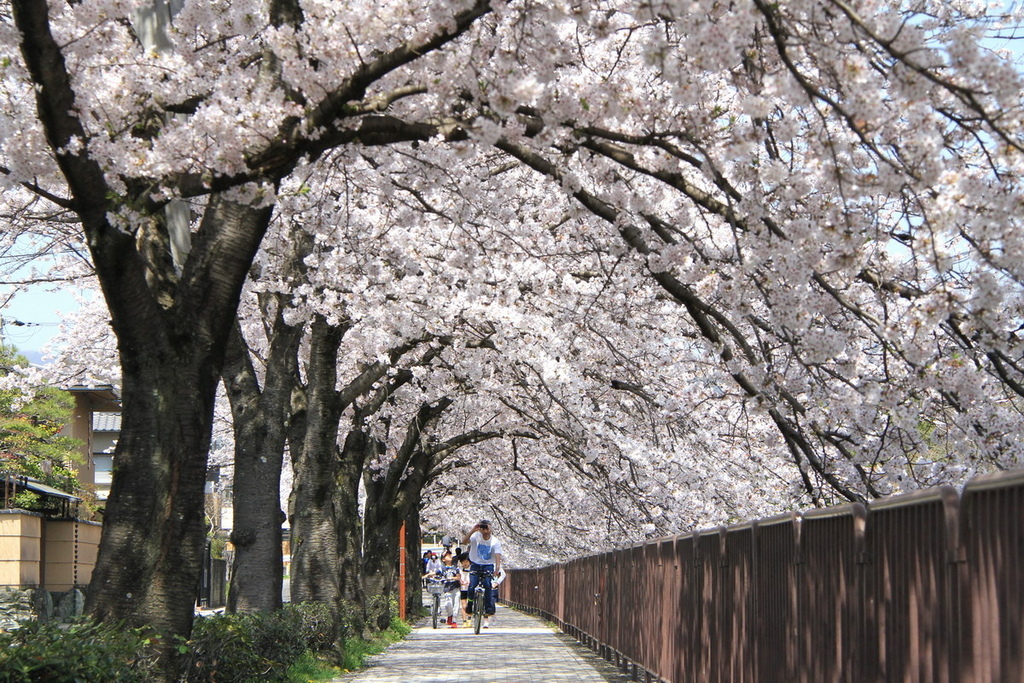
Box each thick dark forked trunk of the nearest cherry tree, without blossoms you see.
[79,198,270,680]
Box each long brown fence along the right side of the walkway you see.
[502,472,1024,683]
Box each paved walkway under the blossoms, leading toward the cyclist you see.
[335,605,629,683]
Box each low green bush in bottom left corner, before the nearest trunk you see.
[0,621,156,683]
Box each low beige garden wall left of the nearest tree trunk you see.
[0,510,102,592]
